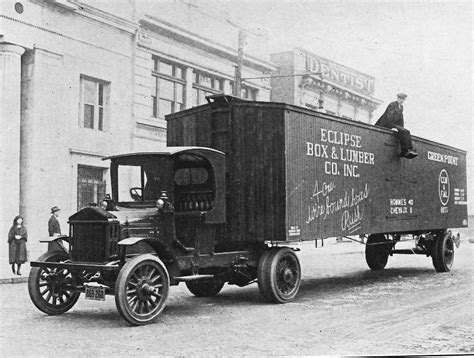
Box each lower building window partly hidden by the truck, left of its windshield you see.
[77,165,106,210]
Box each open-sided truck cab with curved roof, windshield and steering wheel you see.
[104,147,225,256]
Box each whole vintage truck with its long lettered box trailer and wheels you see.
[28,96,467,325]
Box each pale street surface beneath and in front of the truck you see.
[0,228,474,357]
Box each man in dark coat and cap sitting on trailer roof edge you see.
[375,93,418,159]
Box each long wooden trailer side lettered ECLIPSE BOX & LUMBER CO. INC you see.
[285,110,467,241]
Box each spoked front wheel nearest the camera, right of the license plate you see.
[115,254,170,326]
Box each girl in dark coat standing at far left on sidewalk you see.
[8,215,28,276]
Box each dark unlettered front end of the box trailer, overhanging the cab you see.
[167,101,286,246]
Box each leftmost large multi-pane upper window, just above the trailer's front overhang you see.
[151,57,186,118]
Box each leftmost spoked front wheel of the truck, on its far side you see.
[28,251,80,315]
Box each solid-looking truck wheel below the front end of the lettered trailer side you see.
[257,247,301,303]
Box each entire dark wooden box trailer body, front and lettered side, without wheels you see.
[167,97,467,242]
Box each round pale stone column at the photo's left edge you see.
[0,43,25,270]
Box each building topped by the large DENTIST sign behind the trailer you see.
[271,49,382,123]
